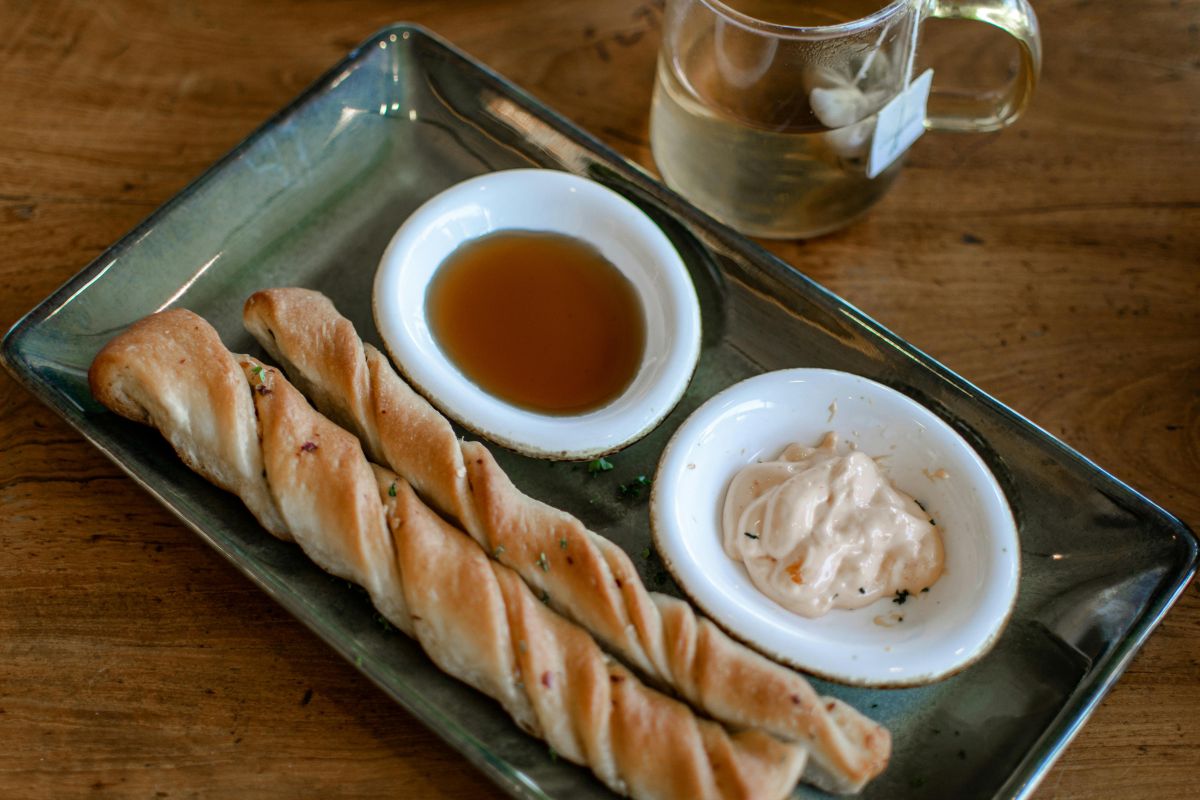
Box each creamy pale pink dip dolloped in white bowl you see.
[722,433,944,616]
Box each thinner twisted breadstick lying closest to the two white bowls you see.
[244,289,892,792]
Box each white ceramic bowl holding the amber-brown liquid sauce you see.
[374,169,700,459]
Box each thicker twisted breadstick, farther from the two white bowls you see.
[89,309,805,799]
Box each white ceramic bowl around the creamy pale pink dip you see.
[650,369,1020,686]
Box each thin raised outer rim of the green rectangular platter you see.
[0,22,1200,800]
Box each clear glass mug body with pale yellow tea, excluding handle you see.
[652,0,912,236]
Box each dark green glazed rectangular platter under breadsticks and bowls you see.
[4,26,1196,799]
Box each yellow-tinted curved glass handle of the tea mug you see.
[925,0,1042,132]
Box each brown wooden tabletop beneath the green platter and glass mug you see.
[0,0,1200,798]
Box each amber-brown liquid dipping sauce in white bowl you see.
[425,230,646,414]
